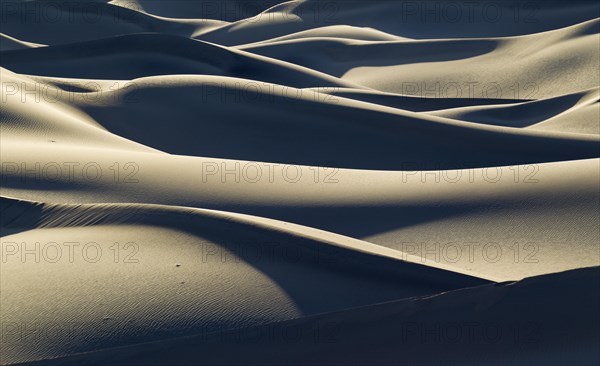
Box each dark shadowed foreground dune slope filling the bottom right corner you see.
[33,268,600,366]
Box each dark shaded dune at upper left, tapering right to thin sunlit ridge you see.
[0,33,354,87]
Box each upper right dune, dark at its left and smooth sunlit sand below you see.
[242,20,600,99]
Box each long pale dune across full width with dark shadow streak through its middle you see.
[2,143,600,279]
